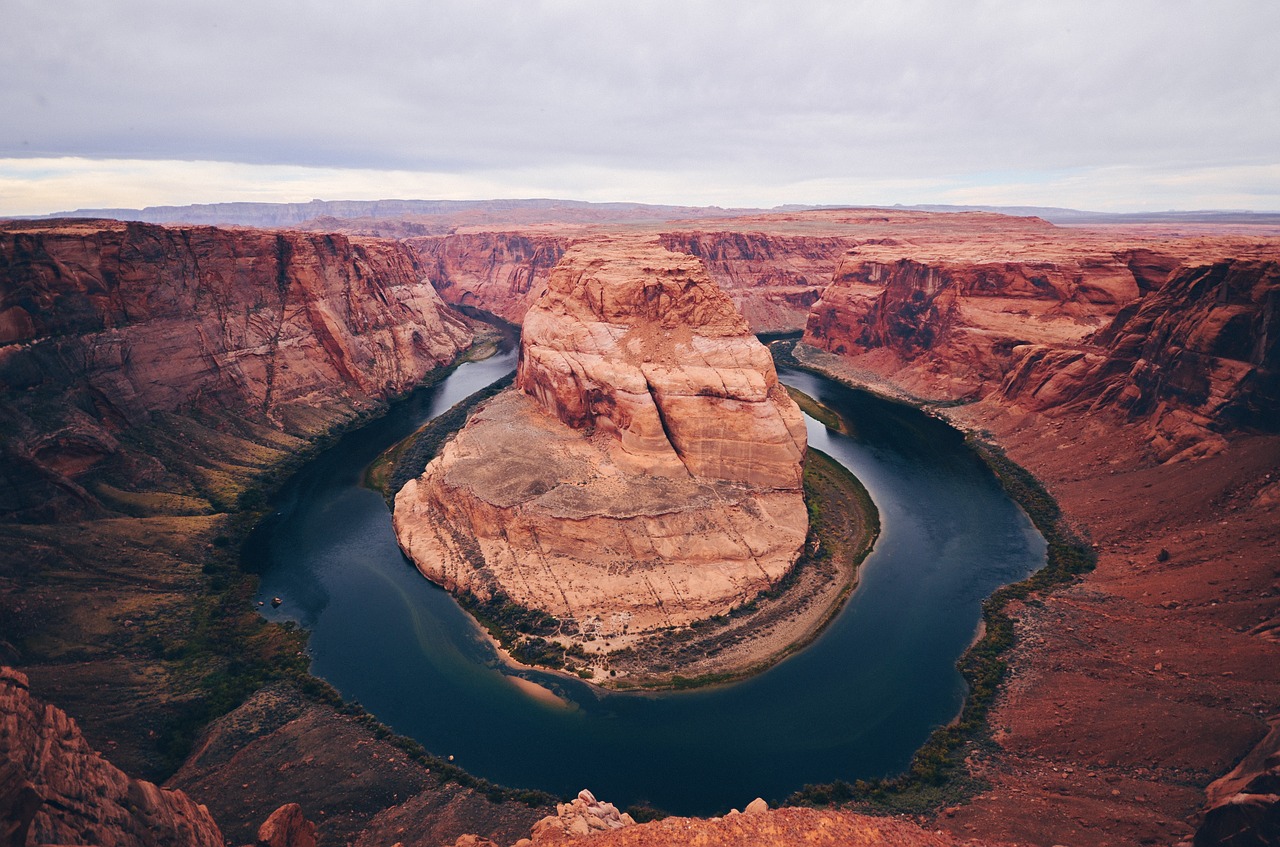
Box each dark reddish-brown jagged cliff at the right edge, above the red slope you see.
[998,261,1280,458]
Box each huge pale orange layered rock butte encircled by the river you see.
[394,241,808,633]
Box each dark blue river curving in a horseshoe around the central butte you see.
[246,352,1044,814]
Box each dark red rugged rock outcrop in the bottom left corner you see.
[0,668,223,847]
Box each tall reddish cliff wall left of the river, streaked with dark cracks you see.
[0,221,470,514]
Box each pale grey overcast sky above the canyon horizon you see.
[0,0,1280,214]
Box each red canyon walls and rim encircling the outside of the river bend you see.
[0,210,1280,844]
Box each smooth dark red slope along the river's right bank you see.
[778,349,1280,846]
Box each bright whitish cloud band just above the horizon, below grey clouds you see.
[0,157,1280,215]
